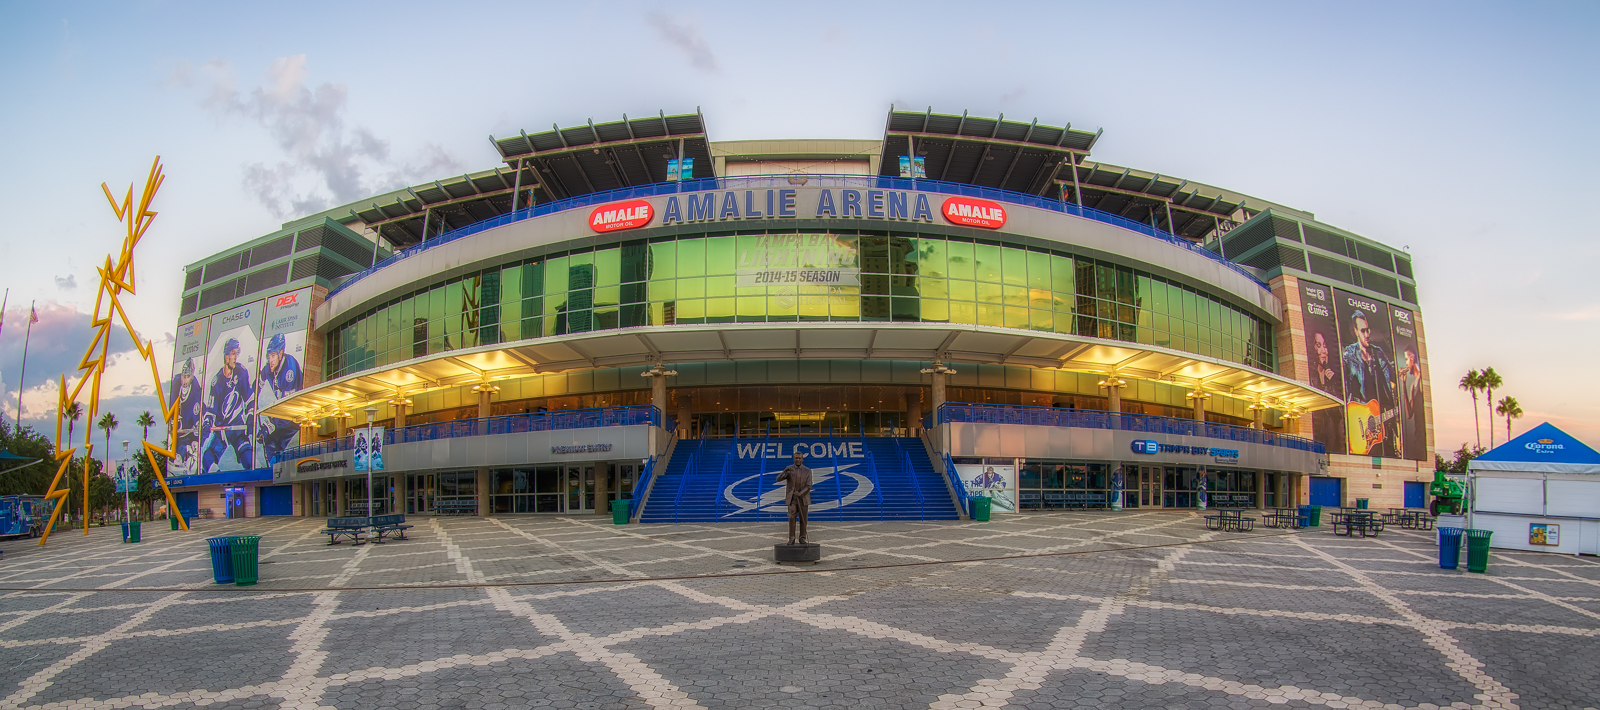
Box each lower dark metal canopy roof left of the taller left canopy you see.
[350,166,538,248]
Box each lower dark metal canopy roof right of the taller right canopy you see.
[1056,160,1245,240]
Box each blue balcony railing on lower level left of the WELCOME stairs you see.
[269,405,661,465]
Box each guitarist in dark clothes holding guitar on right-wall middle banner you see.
[1344,310,1400,457]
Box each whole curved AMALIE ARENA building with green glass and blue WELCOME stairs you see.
[159,110,1434,521]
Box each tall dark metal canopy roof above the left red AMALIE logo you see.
[490,112,715,201]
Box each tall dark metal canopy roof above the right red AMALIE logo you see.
[878,107,1101,195]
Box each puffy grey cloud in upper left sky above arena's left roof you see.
[171,54,461,217]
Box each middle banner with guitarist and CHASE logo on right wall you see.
[1333,291,1400,459]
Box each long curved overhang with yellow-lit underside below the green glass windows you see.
[266,323,1338,421]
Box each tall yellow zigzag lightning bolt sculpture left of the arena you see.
[38,155,189,545]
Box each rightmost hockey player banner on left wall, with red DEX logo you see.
[256,288,310,467]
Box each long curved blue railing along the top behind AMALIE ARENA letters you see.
[328,174,1269,297]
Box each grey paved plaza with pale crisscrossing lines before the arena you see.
[0,512,1600,710]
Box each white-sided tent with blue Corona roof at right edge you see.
[1467,422,1600,555]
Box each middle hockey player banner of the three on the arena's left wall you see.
[200,301,266,473]
